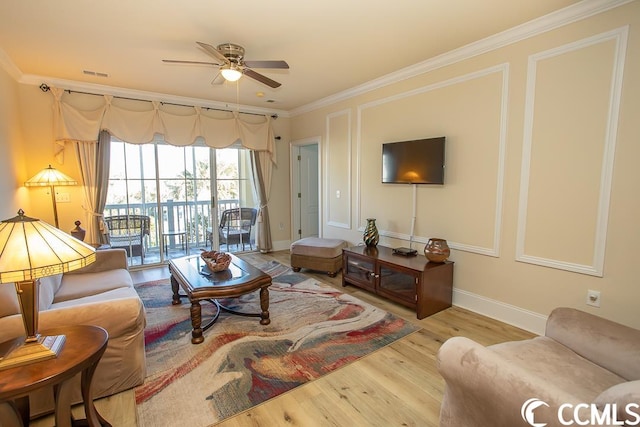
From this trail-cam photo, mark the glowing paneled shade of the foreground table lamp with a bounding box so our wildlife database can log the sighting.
[0,209,96,283]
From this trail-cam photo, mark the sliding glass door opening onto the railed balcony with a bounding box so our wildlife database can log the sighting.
[104,138,255,265]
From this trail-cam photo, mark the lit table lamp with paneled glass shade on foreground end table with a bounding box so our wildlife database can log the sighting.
[0,209,96,370]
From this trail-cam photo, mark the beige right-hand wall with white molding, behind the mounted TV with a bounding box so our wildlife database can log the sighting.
[291,2,640,332]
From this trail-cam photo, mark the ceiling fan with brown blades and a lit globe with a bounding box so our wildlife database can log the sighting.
[162,42,289,88]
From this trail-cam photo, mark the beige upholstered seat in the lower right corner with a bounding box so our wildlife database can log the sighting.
[437,308,640,427]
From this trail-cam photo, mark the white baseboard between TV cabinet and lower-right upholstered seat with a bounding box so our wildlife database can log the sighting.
[453,289,547,335]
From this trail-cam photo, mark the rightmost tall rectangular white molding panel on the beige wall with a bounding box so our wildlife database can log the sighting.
[516,27,629,277]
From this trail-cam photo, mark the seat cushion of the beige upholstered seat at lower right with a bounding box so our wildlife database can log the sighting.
[489,337,624,402]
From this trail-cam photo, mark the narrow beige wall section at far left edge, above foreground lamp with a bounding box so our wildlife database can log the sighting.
[0,67,29,220]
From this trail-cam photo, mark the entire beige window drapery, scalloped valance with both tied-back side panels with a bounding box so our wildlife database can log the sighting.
[51,88,276,252]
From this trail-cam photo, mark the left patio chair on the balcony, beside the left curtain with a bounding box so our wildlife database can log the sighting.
[104,215,150,263]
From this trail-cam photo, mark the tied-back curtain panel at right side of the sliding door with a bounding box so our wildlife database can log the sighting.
[251,151,273,253]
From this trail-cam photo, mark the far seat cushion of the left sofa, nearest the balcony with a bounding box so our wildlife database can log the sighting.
[53,269,133,303]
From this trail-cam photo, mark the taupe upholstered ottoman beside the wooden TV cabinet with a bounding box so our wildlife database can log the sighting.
[291,237,347,277]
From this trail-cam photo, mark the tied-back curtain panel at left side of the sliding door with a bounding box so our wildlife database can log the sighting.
[73,131,111,244]
